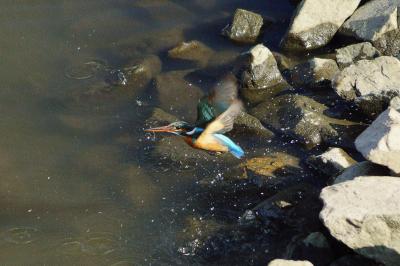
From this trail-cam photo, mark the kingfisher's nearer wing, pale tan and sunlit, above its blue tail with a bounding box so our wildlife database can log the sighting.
[199,99,243,138]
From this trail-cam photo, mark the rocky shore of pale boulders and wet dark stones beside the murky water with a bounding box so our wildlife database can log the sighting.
[122,0,400,266]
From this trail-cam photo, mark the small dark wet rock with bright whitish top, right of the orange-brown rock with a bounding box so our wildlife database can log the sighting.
[307,148,356,176]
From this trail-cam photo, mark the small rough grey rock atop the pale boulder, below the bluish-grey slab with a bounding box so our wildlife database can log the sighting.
[336,42,379,69]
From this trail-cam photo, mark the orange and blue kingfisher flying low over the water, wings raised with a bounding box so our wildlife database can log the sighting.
[145,73,244,159]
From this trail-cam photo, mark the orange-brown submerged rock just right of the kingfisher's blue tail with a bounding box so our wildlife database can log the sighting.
[239,152,302,187]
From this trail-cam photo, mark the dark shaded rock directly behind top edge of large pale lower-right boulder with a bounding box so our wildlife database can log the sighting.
[333,161,389,184]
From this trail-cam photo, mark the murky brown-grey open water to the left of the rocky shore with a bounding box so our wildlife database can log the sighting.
[0,0,293,265]
